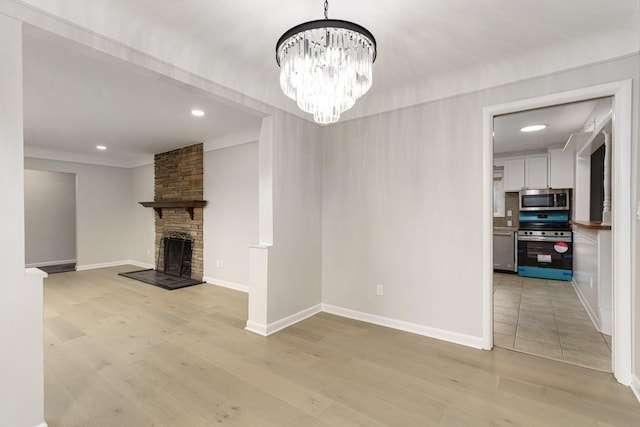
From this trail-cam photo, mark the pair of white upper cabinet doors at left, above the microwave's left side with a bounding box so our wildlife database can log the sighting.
[504,156,548,191]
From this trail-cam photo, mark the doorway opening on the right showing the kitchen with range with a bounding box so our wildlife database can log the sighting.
[493,97,612,372]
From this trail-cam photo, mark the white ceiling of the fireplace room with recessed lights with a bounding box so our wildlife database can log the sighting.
[23,31,261,166]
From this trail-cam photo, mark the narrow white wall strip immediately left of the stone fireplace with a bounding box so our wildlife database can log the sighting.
[129,164,157,268]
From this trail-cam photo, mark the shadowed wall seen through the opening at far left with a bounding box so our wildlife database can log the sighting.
[24,170,76,267]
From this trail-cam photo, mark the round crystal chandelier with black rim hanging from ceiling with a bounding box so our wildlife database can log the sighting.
[276,1,376,124]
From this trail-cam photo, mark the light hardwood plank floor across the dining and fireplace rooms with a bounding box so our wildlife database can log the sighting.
[44,266,640,427]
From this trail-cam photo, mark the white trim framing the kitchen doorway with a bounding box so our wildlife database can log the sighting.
[482,79,633,385]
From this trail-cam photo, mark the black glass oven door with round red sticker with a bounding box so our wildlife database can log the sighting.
[518,241,573,270]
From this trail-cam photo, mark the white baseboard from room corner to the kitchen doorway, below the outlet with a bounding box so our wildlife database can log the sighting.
[322,304,483,349]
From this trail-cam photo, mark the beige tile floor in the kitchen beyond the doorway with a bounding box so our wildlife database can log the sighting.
[493,273,611,372]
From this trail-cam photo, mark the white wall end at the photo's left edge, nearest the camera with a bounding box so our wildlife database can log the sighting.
[0,14,44,427]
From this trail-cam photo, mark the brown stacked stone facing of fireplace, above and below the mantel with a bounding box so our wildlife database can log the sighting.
[154,144,203,280]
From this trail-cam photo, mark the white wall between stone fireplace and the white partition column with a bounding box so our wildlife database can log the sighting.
[204,142,258,289]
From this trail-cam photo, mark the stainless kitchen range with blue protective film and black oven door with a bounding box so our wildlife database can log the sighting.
[517,211,573,281]
